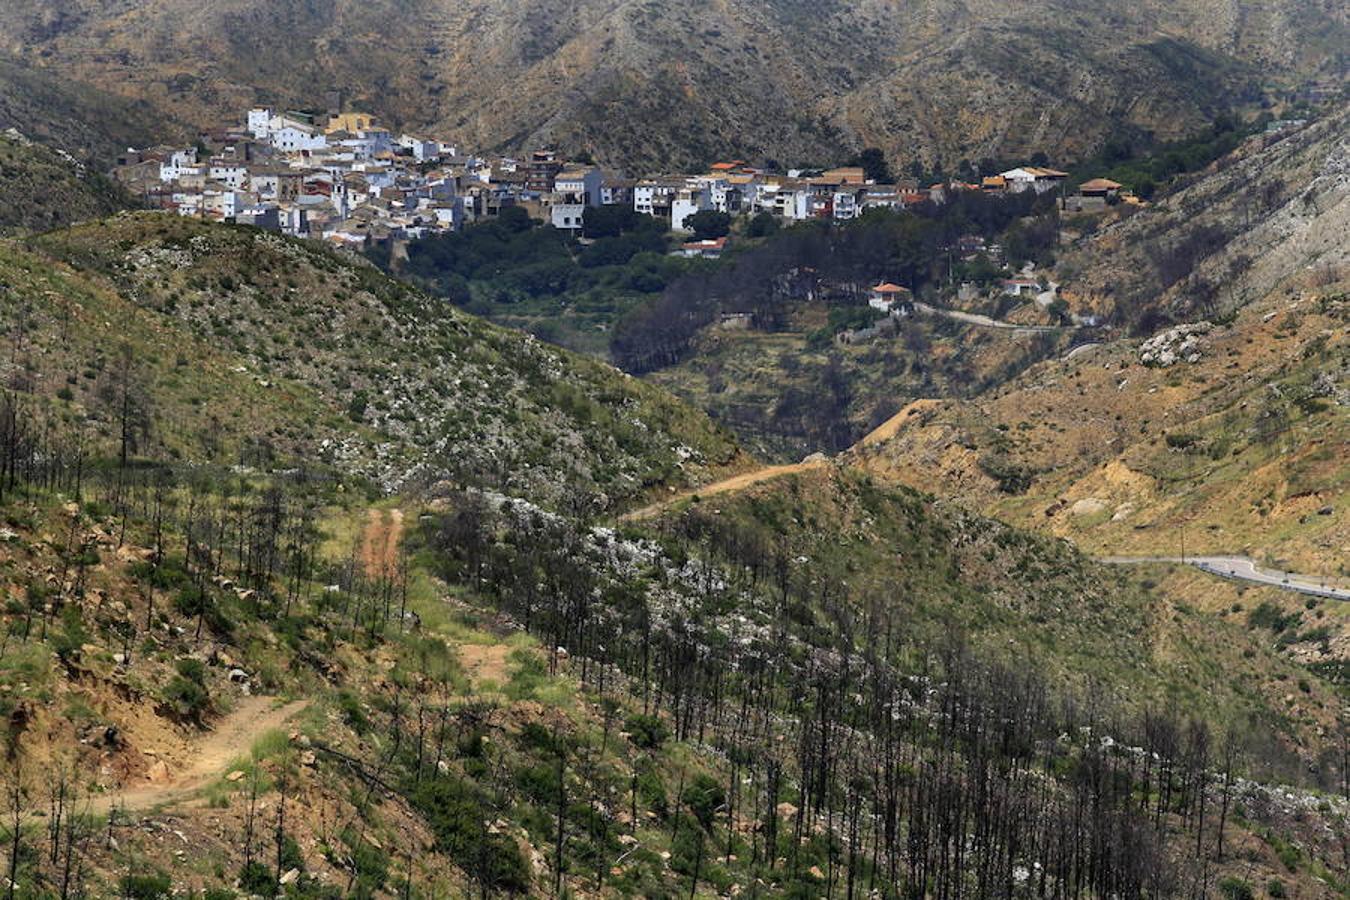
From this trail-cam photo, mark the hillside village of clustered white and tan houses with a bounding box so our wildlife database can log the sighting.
[113,108,1137,258]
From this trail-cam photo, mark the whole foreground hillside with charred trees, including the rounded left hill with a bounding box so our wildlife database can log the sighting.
[0,213,1347,899]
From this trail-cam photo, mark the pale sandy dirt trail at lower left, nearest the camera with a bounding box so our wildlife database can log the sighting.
[74,696,309,815]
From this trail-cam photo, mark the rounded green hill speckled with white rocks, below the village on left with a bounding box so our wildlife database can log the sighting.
[7,213,738,507]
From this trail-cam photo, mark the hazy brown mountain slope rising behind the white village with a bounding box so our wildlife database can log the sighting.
[0,0,1347,169]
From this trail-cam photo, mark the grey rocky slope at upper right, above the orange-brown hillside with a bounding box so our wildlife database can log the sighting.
[1061,107,1350,331]
